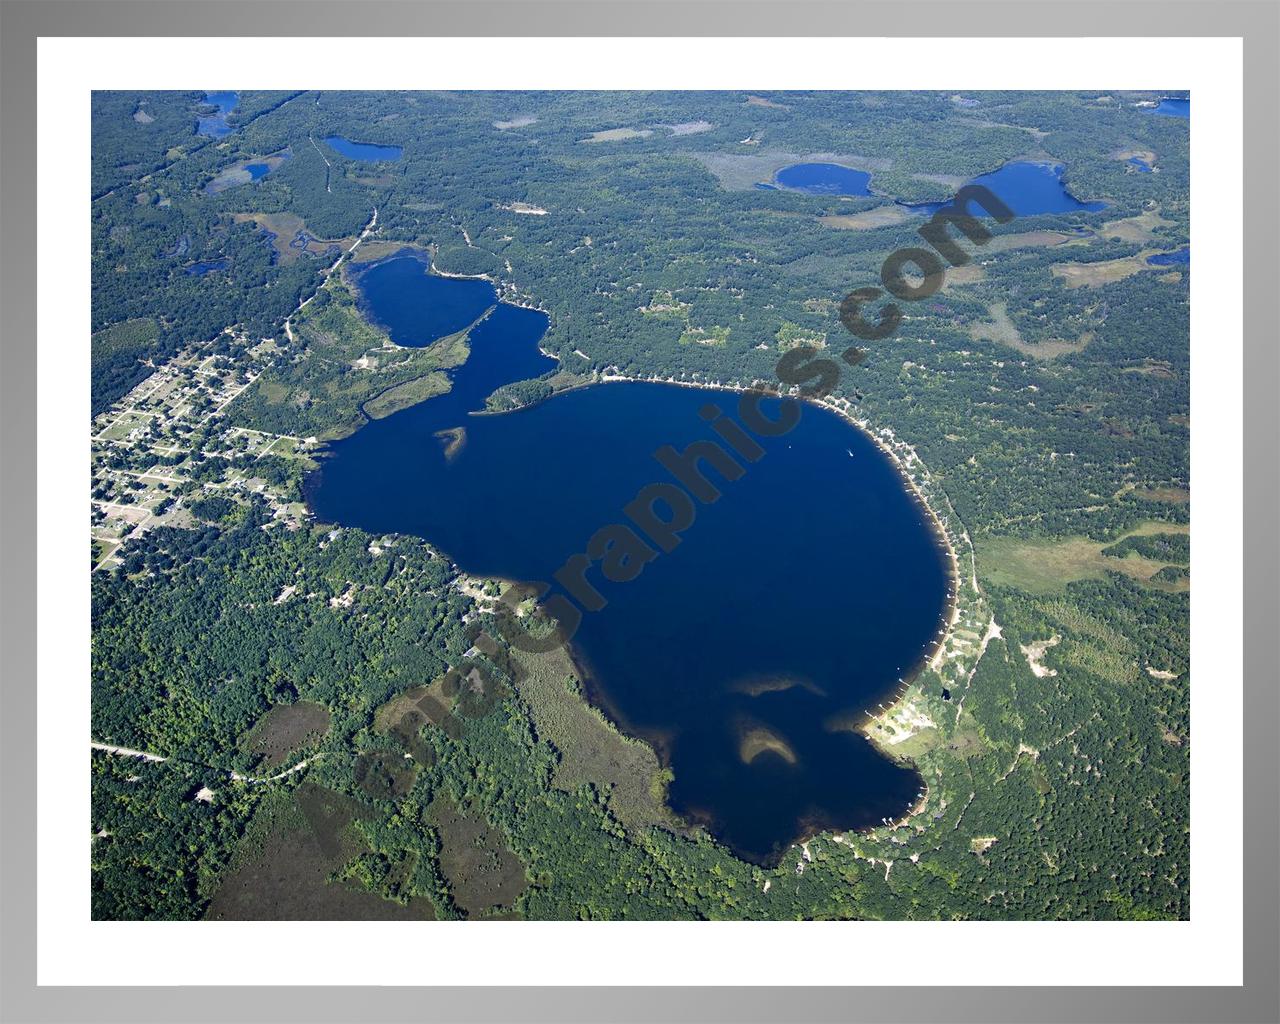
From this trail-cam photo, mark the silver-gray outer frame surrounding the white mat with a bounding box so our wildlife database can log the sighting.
[0,0,1280,1024]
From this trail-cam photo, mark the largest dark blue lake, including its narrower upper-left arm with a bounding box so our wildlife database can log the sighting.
[307,257,948,863]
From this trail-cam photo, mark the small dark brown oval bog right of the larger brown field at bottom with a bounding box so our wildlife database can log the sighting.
[428,794,529,916]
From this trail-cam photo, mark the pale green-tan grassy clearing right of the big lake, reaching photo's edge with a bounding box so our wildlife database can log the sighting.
[978,522,1189,594]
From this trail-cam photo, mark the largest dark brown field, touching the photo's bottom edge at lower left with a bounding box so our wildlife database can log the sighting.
[205,782,435,920]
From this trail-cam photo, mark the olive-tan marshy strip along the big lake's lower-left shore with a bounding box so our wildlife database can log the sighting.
[512,649,673,828]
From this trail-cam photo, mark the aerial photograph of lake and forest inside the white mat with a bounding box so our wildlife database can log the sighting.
[87,81,1192,934]
